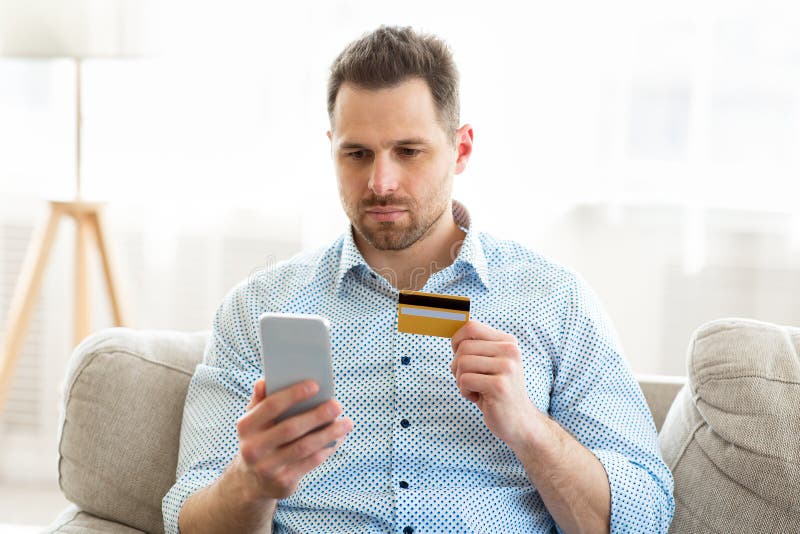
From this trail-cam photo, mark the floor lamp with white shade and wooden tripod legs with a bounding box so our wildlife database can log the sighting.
[0,0,158,411]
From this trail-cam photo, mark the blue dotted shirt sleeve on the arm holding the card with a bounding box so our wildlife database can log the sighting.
[550,276,675,533]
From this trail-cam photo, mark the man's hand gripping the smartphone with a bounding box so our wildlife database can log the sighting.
[236,379,353,499]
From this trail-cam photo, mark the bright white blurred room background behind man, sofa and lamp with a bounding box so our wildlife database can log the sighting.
[0,0,800,522]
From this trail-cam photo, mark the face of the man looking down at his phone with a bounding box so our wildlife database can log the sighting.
[328,78,471,250]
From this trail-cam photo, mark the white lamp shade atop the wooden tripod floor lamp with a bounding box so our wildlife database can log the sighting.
[0,0,158,59]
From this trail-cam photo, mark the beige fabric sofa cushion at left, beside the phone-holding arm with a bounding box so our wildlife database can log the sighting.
[59,328,207,532]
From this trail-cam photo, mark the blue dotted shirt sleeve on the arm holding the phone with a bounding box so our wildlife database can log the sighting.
[162,284,261,534]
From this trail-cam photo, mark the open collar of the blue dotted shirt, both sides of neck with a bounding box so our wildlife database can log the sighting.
[335,200,489,296]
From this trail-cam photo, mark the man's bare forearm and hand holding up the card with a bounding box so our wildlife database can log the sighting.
[450,321,611,532]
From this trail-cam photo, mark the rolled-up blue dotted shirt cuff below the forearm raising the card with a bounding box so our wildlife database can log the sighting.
[592,450,675,534]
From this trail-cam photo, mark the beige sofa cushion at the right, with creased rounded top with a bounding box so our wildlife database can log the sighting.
[659,319,800,532]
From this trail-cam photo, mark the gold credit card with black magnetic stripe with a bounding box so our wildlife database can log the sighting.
[397,290,469,337]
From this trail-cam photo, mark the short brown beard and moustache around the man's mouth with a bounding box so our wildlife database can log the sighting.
[344,194,449,250]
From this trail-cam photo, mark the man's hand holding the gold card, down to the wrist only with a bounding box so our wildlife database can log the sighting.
[450,321,543,451]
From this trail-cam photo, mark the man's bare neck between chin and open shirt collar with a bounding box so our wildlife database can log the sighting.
[353,209,466,290]
